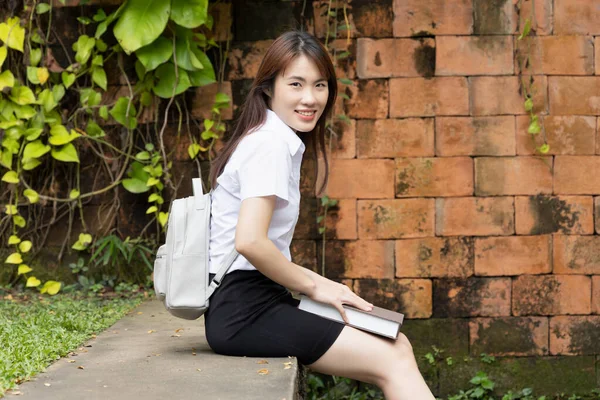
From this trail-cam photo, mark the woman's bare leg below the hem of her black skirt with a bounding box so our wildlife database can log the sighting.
[308,326,435,400]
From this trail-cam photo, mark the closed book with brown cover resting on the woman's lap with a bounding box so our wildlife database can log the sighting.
[298,295,404,339]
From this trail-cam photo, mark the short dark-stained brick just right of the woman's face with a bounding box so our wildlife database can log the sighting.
[346,79,389,119]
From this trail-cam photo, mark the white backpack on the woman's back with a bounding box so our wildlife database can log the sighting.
[154,178,238,319]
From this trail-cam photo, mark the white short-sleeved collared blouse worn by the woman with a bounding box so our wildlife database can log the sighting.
[209,110,305,274]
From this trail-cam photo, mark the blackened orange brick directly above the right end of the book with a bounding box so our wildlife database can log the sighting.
[354,279,432,318]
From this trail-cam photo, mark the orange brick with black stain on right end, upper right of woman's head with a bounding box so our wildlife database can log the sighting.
[356,38,439,79]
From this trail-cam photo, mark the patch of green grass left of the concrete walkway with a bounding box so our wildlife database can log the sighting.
[0,290,143,397]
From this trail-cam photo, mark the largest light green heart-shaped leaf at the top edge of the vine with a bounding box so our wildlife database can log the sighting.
[114,0,171,54]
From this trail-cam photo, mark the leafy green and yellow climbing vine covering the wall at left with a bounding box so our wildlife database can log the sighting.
[0,0,230,294]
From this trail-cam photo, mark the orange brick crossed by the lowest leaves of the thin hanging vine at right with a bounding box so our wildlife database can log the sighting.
[517,115,596,155]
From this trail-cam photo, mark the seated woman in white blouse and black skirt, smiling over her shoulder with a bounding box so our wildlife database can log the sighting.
[205,32,434,400]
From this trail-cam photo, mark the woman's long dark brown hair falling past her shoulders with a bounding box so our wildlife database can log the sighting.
[210,31,337,194]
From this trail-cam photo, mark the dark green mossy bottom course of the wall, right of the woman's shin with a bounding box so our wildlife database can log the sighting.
[436,356,597,398]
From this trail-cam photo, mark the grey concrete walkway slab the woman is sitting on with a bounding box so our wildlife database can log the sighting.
[6,300,298,400]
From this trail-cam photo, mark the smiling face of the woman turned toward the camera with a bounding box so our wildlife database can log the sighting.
[269,55,329,132]
